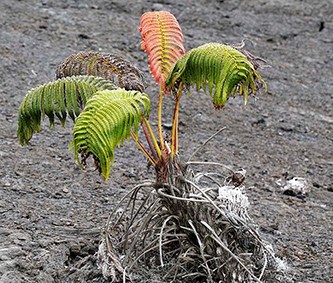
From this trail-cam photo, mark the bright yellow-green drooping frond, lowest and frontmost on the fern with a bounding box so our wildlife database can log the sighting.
[72,89,150,179]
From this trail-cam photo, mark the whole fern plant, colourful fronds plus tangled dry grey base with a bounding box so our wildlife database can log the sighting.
[17,11,280,282]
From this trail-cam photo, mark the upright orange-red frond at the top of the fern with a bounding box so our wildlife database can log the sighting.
[139,11,185,90]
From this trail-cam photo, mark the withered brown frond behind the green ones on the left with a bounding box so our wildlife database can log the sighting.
[56,52,145,92]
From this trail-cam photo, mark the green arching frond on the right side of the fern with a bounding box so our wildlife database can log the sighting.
[166,43,266,108]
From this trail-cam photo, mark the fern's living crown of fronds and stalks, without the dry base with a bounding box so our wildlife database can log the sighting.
[17,11,263,183]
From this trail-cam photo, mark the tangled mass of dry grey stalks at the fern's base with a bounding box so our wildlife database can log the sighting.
[99,163,284,283]
